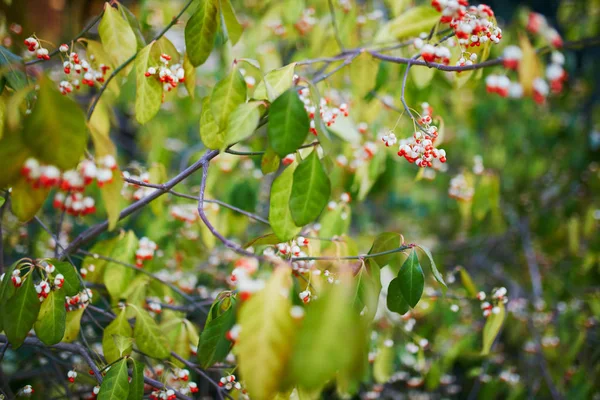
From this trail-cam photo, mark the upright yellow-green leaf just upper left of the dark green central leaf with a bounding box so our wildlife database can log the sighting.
[210,68,246,130]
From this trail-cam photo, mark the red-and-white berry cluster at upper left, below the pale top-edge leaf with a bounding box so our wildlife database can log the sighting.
[58,44,110,95]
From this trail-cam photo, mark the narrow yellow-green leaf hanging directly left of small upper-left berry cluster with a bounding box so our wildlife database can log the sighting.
[135,42,163,124]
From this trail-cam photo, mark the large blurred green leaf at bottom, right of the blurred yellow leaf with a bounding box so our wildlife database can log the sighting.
[289,276,367,389]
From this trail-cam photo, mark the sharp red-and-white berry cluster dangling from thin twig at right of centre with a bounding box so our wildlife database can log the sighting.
[396,103,446,168]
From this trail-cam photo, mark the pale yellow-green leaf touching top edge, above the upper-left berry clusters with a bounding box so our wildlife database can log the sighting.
[98,3,138,76]
